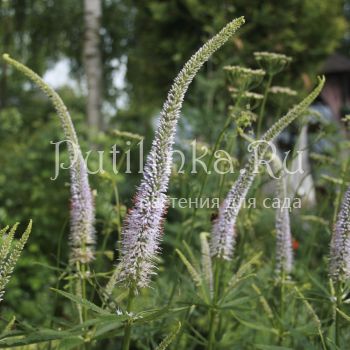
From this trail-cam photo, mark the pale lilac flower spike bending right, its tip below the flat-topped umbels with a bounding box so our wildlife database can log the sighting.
[210,77,325,260]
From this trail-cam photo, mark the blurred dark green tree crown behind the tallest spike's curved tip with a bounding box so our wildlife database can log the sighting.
[127,0,345,141]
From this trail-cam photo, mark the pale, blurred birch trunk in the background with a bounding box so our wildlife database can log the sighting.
[83,0,103,130]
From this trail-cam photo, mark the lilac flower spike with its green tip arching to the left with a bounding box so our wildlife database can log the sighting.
[3,54,95,263]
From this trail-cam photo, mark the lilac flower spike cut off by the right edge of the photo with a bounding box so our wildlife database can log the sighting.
[329,187,350,281]
